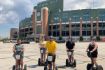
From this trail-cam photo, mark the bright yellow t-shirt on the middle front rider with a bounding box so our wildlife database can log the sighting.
[46,41,56,54]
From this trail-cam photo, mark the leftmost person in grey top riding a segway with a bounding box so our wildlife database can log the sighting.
[13,39,27,70]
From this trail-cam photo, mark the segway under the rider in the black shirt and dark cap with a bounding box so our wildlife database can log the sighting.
[66,50,76,67]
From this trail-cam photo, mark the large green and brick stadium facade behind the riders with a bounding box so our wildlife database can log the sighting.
[19,0,105,40]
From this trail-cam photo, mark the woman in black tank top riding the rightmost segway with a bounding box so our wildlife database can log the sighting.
[86,38,103,70]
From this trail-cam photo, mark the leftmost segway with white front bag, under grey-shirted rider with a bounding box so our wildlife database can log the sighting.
[12,51,27,70]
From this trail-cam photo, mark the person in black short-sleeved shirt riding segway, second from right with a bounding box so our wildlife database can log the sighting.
[66,38,76,67]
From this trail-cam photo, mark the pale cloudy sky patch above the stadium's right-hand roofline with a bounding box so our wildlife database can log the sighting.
[64,0,105,10]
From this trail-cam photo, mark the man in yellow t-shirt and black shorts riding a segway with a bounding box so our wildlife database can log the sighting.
[44,36,57,70]
